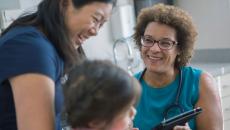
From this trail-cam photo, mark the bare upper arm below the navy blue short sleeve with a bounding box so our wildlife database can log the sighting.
[10,73,55,130]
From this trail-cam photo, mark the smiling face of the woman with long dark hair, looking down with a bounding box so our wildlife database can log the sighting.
[66,1,112,47]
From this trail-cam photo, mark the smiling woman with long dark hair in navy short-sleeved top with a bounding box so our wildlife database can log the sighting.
[0,0,116,130]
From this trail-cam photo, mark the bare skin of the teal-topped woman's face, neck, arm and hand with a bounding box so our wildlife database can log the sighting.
[141,22,223,130]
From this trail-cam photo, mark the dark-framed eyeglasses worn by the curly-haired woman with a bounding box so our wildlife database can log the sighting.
[141,36,177,50]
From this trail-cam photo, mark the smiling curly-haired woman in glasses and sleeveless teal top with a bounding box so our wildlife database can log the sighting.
[134,4,223,130]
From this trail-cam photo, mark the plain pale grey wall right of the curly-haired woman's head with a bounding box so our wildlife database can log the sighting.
[177,0,230,49]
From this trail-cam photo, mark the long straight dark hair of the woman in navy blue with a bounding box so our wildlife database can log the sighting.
[2,0,116,71]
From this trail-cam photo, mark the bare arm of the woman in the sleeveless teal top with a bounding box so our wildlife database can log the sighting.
[196,73,223,130]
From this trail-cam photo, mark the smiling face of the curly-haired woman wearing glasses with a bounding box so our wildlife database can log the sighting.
[141,22,179,73]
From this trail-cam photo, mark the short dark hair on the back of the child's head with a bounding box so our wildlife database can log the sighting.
[64,60,140,128]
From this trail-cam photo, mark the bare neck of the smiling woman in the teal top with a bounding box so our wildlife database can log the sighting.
[143,69,178,88]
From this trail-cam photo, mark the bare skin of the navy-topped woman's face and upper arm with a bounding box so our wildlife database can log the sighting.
[9,0,112,130]
